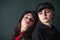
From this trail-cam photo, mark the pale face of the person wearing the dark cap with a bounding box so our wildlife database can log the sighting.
[38,8,54,23]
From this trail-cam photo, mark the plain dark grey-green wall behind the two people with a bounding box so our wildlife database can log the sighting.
[0,0,60,40]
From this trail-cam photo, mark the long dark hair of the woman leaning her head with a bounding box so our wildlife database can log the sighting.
[13,11,37,40]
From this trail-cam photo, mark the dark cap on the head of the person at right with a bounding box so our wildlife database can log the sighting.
[36,2,55,12]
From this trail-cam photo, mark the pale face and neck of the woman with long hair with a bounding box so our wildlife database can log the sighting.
[21,13,34,32]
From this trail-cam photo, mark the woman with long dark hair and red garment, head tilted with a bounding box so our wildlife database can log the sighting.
[13,11,37,40]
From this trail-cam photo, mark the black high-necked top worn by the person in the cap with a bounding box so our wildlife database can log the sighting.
[32,22,59,40]
